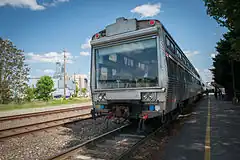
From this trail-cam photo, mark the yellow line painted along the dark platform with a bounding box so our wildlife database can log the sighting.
[204,98,211,160]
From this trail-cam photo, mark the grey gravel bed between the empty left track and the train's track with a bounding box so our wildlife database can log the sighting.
[0,118,123,160]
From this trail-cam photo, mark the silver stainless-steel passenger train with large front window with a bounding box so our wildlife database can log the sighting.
[90,17,205,121]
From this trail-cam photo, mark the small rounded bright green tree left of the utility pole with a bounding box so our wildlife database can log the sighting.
[35,76,54,101]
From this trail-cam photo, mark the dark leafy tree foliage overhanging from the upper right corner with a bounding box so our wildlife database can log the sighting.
[204,0,240,60]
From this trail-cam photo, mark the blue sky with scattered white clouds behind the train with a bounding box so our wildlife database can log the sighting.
[0,0,226,80]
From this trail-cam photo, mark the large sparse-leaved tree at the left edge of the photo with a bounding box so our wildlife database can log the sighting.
[0,38,29,103]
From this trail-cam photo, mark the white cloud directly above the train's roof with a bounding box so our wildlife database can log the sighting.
[131,3,161,18]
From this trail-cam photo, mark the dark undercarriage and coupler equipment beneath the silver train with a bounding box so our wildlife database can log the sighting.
[91,94,202,131]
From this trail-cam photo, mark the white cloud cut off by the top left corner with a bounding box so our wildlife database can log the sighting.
[0,0,45,10]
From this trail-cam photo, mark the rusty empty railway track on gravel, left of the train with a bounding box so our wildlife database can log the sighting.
[0,106,91,140]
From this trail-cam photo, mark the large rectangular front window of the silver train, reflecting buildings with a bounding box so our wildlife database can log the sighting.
[95,37,158,89]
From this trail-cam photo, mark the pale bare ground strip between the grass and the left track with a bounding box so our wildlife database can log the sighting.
[0,102,92,117]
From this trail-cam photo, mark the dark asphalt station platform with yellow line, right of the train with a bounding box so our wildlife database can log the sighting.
[160,96,240,160]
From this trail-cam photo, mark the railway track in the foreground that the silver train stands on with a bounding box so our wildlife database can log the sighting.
[49,110,184,160]
